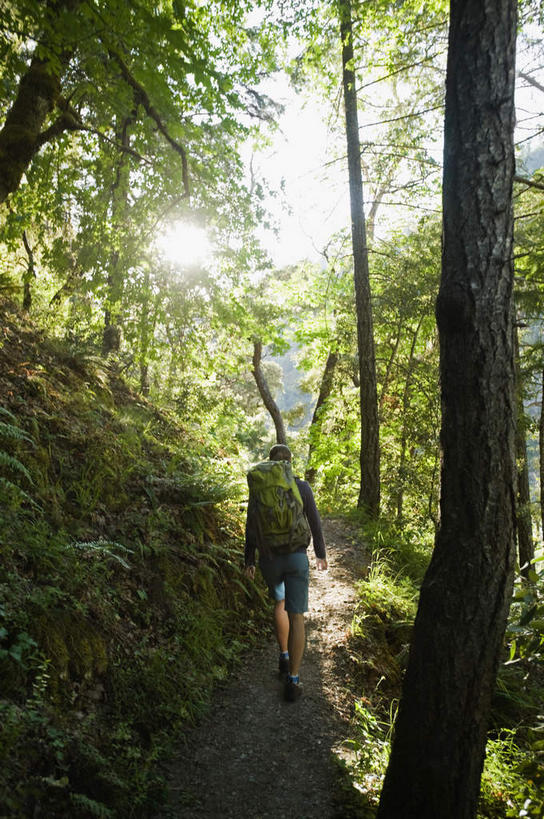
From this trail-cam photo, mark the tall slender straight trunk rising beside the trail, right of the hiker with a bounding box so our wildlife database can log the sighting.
[338,0,380,517]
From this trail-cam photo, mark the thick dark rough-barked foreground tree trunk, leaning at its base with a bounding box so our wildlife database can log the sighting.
[377,0,516,819]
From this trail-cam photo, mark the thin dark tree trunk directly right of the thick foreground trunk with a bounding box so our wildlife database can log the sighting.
[514,326,535,578]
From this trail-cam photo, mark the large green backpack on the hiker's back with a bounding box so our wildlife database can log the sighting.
[247,461,311,554]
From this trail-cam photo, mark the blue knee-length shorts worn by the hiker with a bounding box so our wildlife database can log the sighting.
[259,552,310,614]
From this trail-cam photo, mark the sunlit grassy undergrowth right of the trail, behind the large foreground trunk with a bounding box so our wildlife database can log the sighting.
[336,522,544,819]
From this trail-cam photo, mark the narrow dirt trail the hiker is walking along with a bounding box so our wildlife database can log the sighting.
[162,520,366,819]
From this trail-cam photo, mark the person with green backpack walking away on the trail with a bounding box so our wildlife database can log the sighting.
[245,444,327,702]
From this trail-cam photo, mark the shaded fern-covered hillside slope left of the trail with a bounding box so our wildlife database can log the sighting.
[0,302,263,817]
